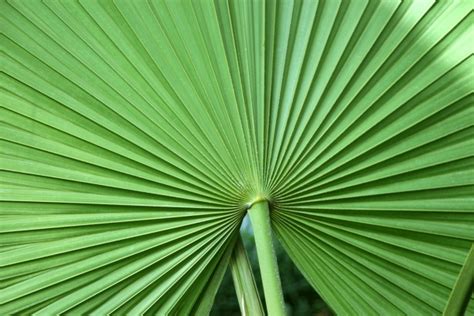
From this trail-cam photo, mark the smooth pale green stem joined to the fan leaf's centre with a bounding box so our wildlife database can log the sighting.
[248,201,285,316]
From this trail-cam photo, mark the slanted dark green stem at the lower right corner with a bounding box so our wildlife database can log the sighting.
[443,243,474,316]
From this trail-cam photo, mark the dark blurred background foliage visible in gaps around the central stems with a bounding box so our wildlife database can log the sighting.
[211,217,333,316]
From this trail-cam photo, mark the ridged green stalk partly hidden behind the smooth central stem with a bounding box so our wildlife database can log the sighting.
[230,236,265,316]
